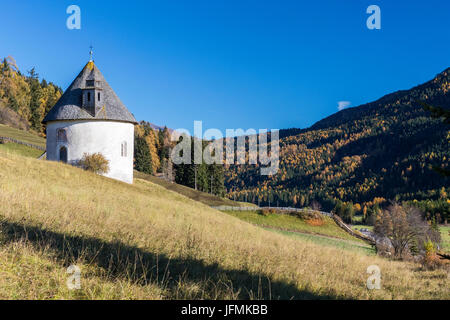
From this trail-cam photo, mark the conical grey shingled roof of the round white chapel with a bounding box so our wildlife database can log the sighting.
[42,61,137,123]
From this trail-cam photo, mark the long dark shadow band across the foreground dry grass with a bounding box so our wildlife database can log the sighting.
[0,220,336,299]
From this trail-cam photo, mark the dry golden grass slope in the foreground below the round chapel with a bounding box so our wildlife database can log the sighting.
[0,151,450,299]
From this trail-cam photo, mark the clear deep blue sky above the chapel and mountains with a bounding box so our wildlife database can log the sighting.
[0,0,450,130]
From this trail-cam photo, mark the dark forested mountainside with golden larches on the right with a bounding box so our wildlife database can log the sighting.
[226,68,450,220]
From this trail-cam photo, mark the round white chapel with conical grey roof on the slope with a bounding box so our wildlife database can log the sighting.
[43,60,137,183]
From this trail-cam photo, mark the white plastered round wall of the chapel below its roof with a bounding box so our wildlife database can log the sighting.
[47,120,134,183]
